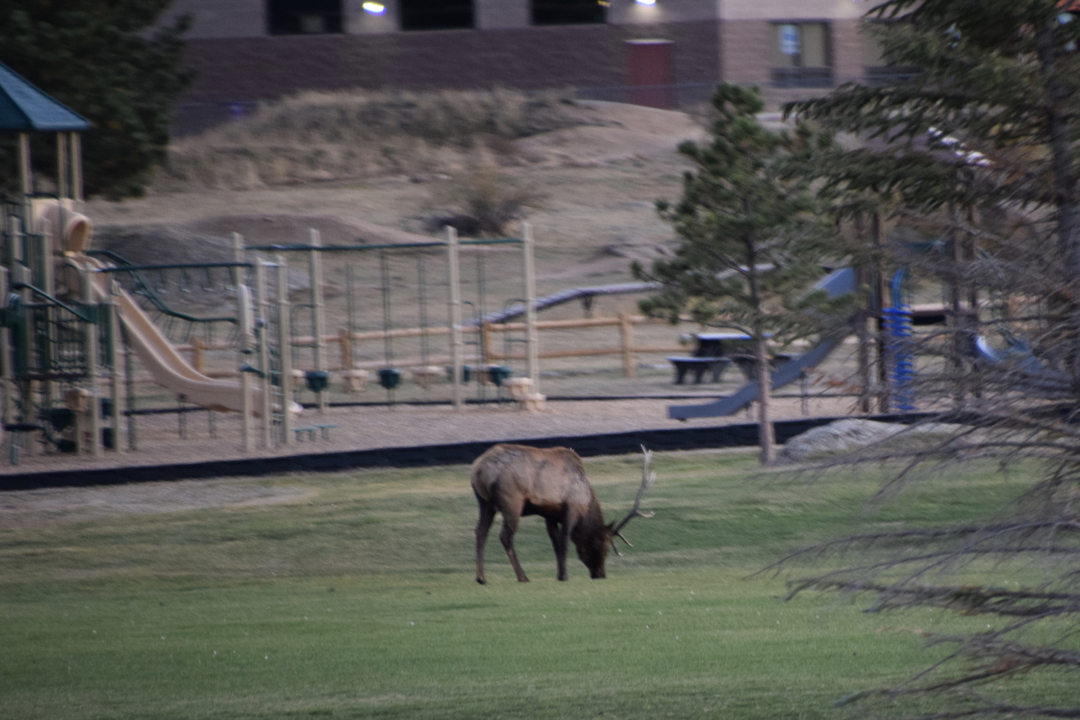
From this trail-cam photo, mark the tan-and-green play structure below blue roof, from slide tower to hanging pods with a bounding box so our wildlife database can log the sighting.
[0,185,543,464]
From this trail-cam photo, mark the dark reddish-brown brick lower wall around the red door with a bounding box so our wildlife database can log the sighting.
[184,22,721,103]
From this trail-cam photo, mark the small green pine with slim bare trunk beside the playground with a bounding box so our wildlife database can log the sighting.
[635,84,823,465]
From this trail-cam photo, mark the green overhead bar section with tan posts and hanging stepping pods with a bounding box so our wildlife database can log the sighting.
[247,225,540,408]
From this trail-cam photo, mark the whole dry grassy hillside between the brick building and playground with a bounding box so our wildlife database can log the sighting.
[87,91,702,289]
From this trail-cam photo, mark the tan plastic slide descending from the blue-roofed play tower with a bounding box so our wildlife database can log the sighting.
[80,258,282,415]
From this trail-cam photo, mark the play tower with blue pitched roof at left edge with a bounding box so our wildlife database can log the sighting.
[0,64,99,462]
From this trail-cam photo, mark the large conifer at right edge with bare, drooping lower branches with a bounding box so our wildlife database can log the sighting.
[786,0,1080,720]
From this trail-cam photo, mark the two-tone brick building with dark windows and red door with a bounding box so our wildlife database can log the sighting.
[170,0,879,131]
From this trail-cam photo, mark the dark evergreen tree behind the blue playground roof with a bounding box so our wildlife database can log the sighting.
[0,0,190,198]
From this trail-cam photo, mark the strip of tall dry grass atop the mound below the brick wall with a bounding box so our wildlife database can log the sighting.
[157,89,581,190]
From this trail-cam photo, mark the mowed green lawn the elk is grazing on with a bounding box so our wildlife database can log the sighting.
[0,452,1045,720]
